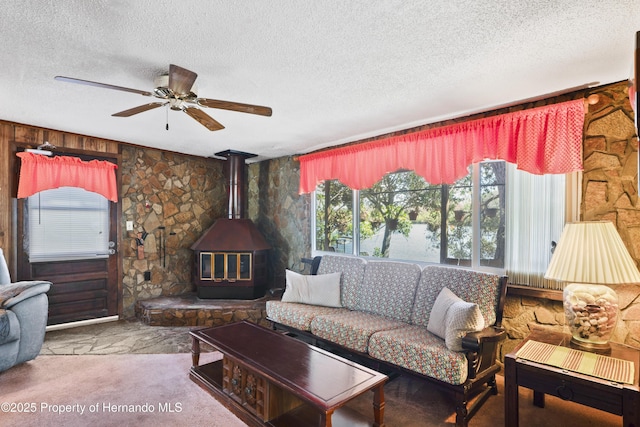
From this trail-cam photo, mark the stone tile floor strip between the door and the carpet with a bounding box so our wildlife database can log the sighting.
[40,319,195,355]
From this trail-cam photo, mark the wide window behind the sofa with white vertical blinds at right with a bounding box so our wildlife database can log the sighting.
[313,161,565,284]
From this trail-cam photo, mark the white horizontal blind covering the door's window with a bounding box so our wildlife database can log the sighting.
[27,187,109,262]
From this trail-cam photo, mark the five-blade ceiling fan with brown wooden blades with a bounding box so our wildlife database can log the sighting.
[54,64,271,131]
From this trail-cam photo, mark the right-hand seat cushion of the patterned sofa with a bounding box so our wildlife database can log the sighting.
[369,326,468,385]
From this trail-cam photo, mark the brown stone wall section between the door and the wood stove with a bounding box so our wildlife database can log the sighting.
[121,146,226,317]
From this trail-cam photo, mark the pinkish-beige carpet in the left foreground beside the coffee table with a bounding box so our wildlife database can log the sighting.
[0,353,245,427]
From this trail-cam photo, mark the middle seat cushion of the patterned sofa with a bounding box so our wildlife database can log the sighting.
[311,311,406,353]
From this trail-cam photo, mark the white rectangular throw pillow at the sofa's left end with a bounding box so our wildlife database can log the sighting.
[282,270,342,307]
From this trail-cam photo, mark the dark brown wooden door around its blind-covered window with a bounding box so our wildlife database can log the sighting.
[17,153,120,325]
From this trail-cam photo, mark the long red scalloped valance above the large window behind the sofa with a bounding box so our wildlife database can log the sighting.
[298,99,585,194]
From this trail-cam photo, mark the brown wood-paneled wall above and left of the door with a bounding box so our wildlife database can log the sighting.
[0,121,121,274]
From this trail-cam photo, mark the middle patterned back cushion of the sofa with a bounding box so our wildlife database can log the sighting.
[358,261,421,322]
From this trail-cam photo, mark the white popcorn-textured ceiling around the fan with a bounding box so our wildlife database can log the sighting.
[0,0,640,160]
